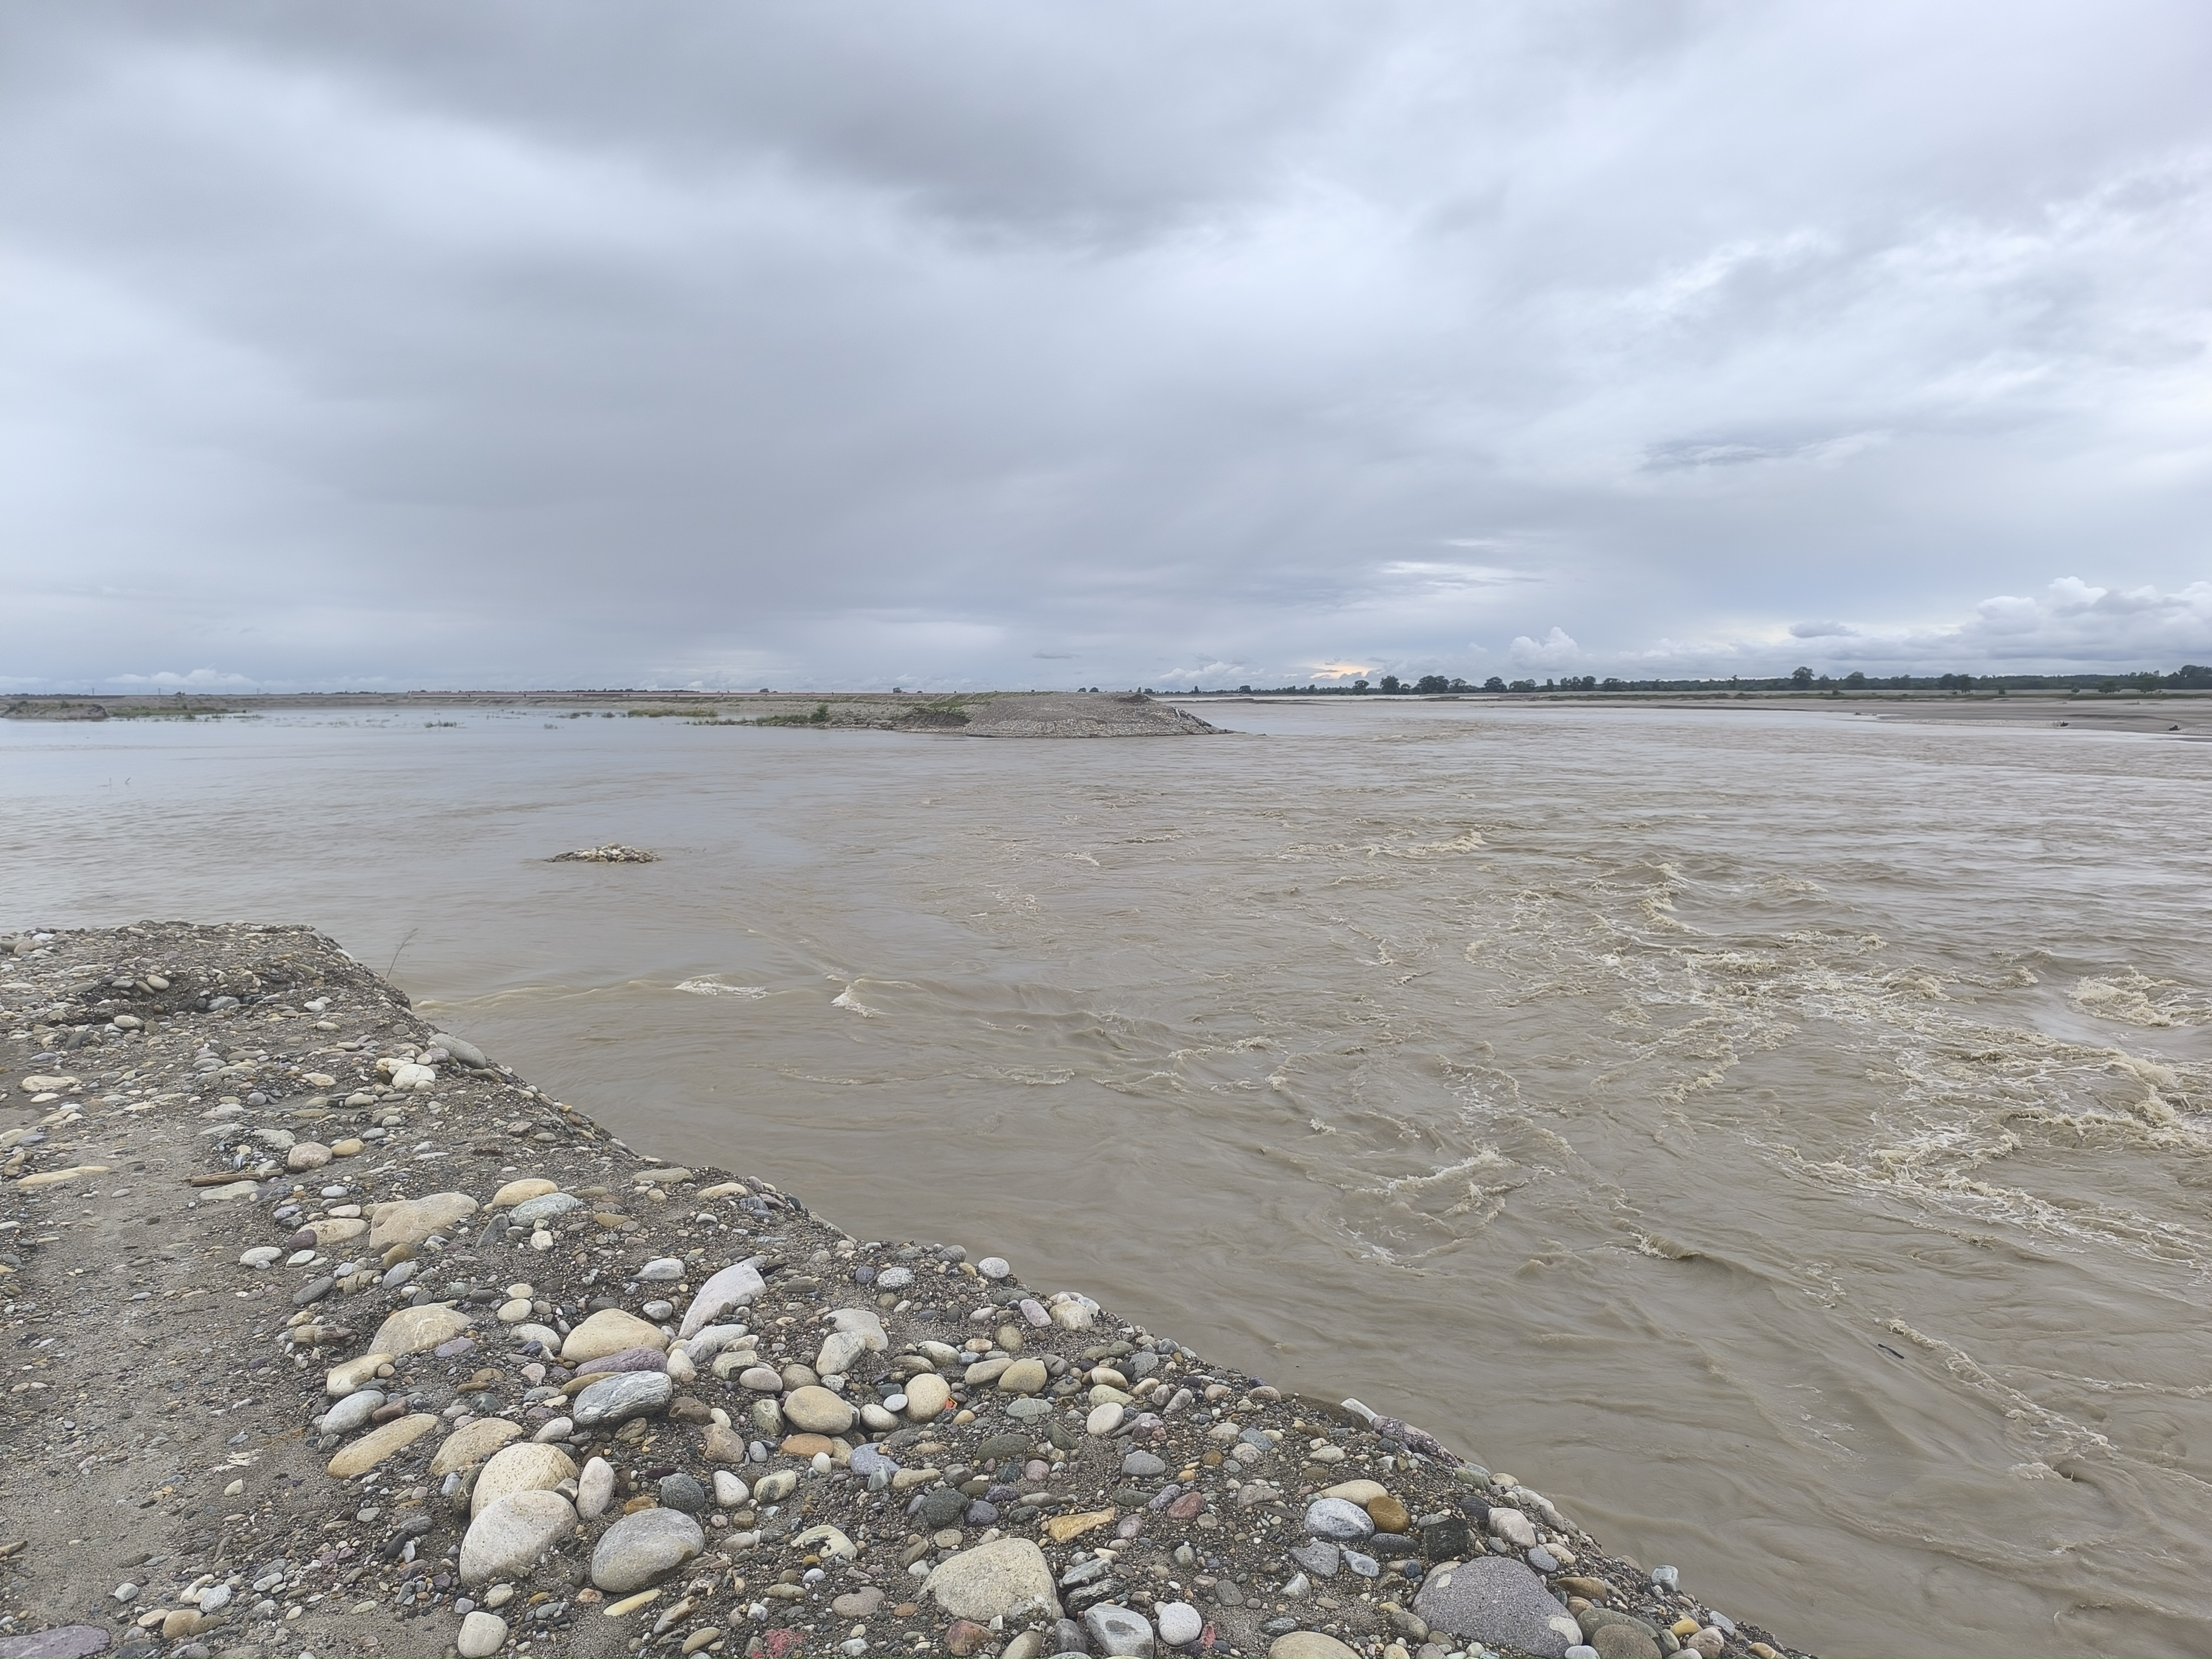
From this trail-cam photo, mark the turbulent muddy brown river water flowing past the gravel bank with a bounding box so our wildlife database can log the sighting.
[0,703,2212,1659]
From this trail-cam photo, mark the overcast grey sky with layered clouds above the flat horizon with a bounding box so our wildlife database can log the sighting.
[0,0,2212,690]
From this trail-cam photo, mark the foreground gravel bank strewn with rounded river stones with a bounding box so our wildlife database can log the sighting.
[0,924,1780,1659]
